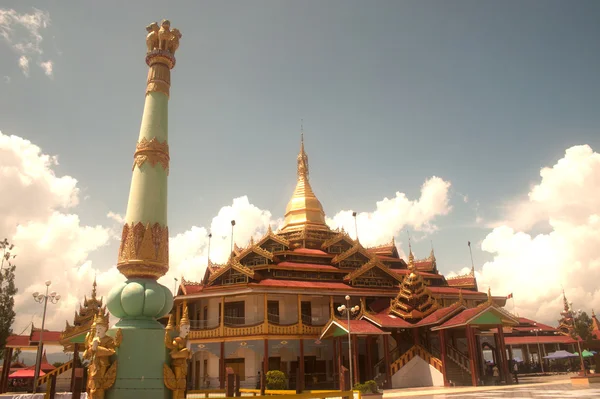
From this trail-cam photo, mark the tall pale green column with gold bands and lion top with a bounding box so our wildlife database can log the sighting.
[106,20,181,399]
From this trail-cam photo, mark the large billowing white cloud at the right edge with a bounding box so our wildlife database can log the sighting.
[478,145,600,324]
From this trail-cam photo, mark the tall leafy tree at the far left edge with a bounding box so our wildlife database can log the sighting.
[0,238,17,355]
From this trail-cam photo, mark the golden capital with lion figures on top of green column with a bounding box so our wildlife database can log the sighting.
[146,19,182,96]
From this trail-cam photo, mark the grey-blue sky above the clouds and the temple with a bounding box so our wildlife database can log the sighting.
[0,0,600,332]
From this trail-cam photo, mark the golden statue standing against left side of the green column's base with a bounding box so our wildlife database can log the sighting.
[83,309,123,399]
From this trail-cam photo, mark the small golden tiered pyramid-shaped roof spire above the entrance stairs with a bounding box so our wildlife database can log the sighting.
[390,251,440,320]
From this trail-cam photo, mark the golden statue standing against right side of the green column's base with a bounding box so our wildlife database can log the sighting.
[163,304,192,399]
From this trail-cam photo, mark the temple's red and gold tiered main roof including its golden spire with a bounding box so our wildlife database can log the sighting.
[178,136,506,323]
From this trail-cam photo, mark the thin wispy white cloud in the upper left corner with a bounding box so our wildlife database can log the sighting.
[0,8,52,76]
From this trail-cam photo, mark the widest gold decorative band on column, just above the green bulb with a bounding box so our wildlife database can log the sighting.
[117,222,169,279]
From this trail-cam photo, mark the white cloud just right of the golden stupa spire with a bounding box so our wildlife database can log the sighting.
[327,176,452,246]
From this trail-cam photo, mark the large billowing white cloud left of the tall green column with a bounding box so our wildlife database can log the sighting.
[0,133,115,332]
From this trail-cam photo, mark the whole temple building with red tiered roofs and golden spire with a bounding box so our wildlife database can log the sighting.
[174,141,520,389]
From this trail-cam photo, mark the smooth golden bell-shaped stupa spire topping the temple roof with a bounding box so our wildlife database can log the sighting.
[281,129,329,232]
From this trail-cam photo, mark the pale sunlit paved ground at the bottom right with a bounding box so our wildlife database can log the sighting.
[384,380,600,399]
